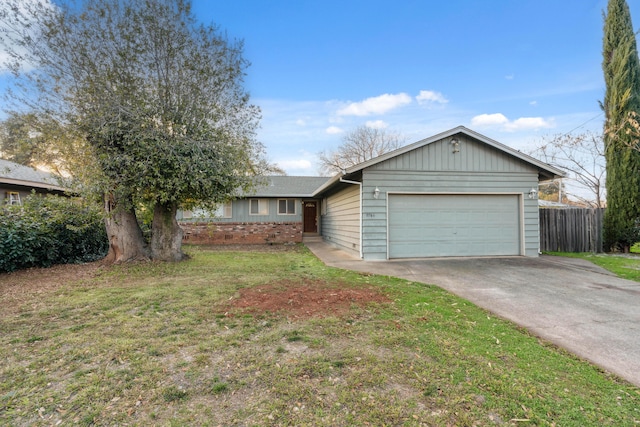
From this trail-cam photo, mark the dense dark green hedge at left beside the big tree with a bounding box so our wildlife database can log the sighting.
[0,195,109,272]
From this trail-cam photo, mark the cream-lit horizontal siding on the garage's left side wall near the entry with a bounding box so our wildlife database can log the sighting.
[321,184,360,256]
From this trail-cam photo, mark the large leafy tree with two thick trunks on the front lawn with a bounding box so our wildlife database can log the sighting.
[2,0,264,261]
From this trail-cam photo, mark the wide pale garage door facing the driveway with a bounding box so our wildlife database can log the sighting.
[389,194,521,258]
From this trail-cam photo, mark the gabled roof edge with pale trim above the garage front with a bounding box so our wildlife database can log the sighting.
[314,126,565,195]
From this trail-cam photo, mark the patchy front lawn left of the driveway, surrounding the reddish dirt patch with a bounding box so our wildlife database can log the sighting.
[0,247,640,426]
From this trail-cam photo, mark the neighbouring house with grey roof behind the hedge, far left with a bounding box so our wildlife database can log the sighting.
[0,159,66,205]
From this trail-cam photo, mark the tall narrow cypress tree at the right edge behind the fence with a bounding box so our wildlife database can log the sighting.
[602,0,640,251]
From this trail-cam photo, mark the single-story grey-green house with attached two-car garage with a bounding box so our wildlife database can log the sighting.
[179,126,564,260]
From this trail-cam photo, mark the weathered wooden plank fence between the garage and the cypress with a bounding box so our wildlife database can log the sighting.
[540,208,604,252]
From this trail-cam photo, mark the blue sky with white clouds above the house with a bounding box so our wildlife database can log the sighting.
[0,0,640,175]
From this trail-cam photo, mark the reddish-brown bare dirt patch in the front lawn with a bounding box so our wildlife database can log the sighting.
[230,280,391,319]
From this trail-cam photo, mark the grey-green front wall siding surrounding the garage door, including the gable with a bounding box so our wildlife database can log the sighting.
[362,139,539,260]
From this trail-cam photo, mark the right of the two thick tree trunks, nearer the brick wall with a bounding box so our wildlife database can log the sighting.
[151,203,186,261]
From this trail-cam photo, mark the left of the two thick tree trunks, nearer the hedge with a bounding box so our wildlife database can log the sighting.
[105,197,150,263]
